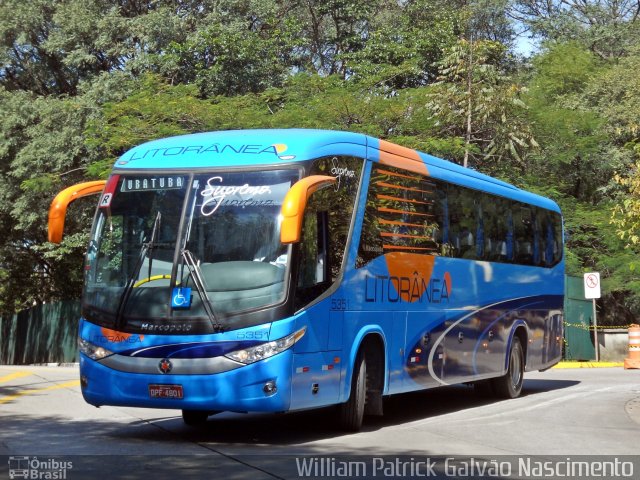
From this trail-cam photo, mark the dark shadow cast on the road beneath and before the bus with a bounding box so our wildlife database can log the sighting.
[0,380,579,455]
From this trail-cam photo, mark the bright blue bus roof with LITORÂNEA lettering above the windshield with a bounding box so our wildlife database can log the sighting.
[115,129,559,211]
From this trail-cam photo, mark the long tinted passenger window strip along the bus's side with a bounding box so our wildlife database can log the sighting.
[357,165,562,267]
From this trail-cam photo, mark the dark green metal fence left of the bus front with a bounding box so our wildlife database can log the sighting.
[0,301,80,365]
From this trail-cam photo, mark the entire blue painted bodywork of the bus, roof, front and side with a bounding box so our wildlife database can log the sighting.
[80,129,564,412]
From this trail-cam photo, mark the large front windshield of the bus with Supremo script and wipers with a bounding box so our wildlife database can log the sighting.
[83,169,299,328]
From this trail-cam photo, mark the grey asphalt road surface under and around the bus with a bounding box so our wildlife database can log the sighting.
[0,366,640,480]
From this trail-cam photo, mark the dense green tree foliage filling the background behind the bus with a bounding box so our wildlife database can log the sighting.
[0,0,640,324]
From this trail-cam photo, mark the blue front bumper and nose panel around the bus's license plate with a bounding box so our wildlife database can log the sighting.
[79,319,295,412]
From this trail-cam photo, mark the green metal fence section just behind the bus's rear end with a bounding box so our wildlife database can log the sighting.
[564,276,596,360]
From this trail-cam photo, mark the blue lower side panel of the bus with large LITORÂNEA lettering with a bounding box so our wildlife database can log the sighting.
[318,257,564,401]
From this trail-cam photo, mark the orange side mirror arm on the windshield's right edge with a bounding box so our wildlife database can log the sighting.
[280,175,336,244]
